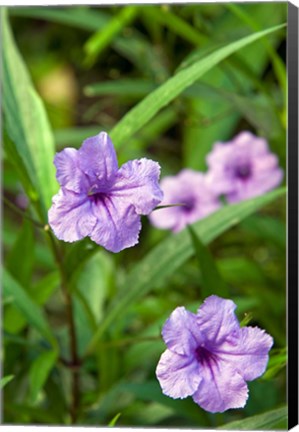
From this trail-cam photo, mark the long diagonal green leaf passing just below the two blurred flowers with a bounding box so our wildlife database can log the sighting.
[87,188,285,353]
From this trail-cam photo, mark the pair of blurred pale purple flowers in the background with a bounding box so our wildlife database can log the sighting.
[150,132,283,232]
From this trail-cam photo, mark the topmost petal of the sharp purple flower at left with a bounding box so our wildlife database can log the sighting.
[78,132,118,186]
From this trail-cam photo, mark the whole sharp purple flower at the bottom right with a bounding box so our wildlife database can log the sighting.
[156,295,273,413]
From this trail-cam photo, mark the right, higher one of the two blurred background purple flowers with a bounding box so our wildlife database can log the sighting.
[207,132,283,203]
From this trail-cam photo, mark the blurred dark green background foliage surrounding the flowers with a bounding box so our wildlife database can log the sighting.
[2,2,287,429]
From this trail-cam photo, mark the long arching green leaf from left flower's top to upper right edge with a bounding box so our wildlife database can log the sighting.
[111,25,284,145]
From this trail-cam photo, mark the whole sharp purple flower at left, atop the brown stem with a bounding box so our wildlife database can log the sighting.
[49,132,163,252]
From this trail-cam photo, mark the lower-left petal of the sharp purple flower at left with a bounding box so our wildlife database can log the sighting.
[48,189,97,242]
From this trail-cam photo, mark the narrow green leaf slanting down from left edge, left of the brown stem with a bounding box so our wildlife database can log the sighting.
[2,269,56,346]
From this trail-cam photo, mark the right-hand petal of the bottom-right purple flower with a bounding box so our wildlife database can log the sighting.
[215,327,273,381]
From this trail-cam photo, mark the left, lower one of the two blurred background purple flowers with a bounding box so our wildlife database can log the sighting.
[150,169,220,232]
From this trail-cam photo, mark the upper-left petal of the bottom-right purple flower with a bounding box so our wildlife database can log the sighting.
[162,307,202,355]
